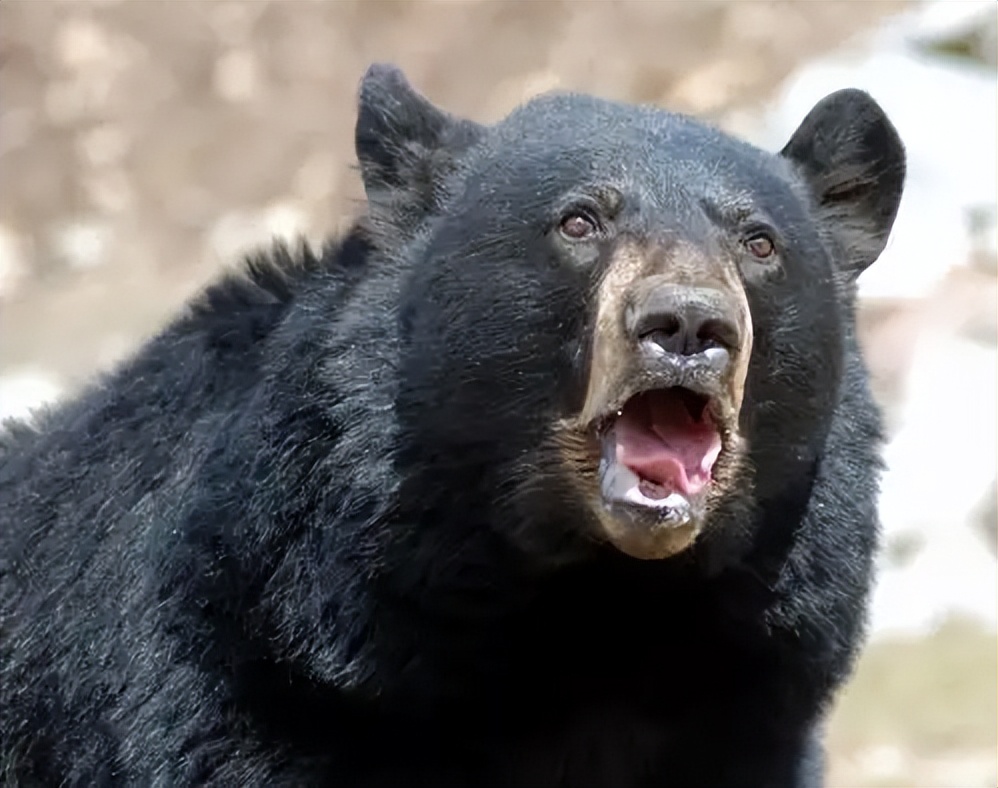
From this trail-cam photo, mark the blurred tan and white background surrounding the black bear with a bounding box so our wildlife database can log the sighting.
[0,0,998,788]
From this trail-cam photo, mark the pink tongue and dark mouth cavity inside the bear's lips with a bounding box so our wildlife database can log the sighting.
[614,392,721,495]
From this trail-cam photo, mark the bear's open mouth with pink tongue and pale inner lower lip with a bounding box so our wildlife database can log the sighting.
[600,387,721,519]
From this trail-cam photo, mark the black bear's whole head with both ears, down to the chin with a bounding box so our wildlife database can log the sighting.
[357,67,904,562]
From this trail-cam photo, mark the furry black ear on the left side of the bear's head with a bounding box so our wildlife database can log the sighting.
[355,64,484,244]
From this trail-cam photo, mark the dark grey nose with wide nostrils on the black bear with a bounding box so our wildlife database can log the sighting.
[627,285,741,356]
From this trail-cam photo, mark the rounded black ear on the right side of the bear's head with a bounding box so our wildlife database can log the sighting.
[780,89,905,278]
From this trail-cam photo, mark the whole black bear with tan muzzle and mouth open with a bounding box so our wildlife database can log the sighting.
[0,66,905,788]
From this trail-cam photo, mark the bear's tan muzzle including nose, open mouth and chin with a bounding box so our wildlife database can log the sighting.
[585,286,748,558]
